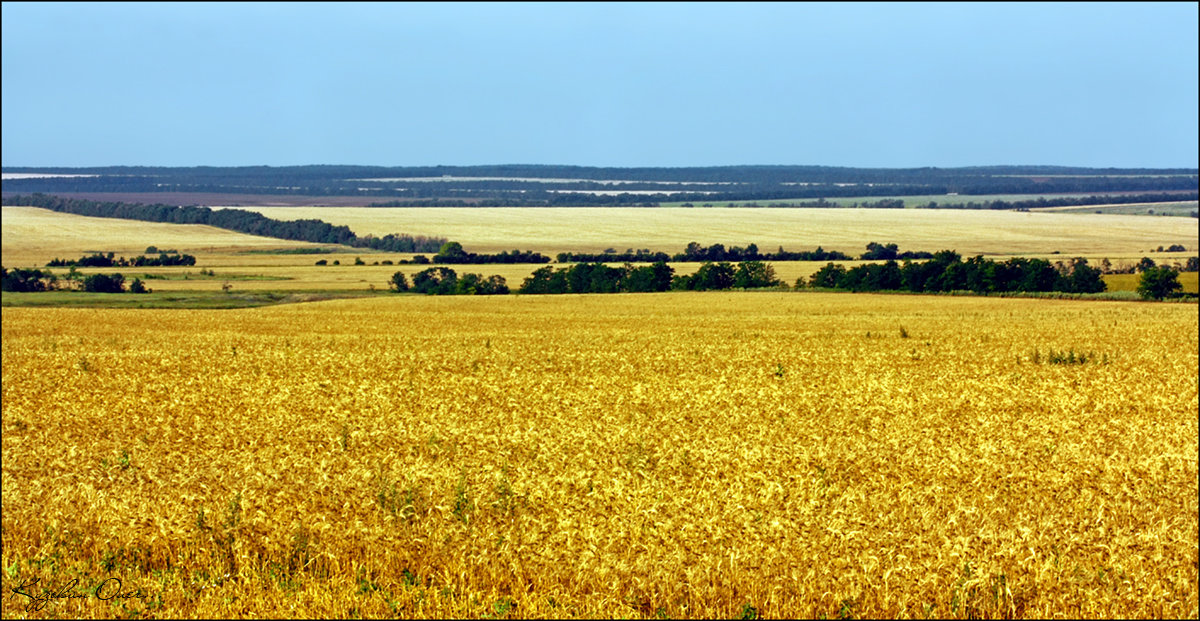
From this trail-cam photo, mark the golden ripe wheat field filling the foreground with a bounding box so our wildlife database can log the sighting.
[0,291,1200,619]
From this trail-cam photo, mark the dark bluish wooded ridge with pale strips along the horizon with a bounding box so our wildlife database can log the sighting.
[4,164,1200,206]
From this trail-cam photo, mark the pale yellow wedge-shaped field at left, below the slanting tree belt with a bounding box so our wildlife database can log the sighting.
[0,207,314,267]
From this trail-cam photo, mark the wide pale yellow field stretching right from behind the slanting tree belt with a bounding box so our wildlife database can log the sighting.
[229,207,1198,257]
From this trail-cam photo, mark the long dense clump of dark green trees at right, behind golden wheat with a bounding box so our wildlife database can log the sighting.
[797,251,1106,294]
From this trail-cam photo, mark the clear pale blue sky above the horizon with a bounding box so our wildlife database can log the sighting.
[0,2,1200,168]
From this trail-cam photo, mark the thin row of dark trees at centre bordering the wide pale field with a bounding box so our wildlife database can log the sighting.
[557,241,934,263]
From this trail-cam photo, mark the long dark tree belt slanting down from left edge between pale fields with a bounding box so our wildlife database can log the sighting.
[4,193,446,252]
